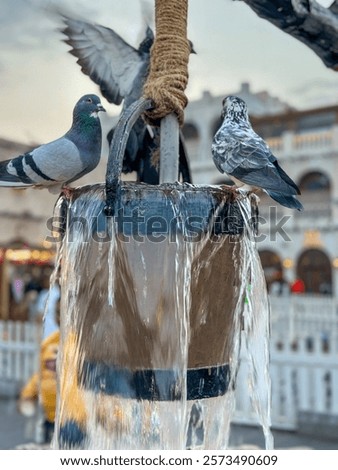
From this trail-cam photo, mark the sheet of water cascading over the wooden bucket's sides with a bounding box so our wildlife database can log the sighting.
[53,183,273,449]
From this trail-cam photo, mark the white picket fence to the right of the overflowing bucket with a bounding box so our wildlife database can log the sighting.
[234,296,338,430]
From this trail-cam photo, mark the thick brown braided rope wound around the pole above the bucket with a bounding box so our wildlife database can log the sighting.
[143,0,191,125]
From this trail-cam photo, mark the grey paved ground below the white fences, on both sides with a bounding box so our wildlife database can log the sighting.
[0,399,338,450]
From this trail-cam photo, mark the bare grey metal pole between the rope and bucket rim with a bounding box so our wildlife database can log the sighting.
[160,113,179,183]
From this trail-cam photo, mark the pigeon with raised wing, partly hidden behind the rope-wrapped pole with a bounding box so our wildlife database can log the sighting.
[61,13,191,184]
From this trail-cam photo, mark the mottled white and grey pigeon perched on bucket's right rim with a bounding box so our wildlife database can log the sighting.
[211,96,303,210]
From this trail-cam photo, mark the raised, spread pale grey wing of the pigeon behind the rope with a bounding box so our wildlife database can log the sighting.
[62,17,143,105]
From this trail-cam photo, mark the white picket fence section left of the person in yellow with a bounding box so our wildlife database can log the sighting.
[0,321,41,393]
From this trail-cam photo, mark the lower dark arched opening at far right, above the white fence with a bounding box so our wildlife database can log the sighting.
[297,248,332,295]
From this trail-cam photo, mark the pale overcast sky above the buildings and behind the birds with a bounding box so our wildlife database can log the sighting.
[0,0,338,143]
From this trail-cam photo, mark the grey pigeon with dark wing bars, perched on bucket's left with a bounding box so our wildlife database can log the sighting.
[0,95,105,193]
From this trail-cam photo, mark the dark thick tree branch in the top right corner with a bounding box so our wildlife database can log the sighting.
[242,0,338,71]
